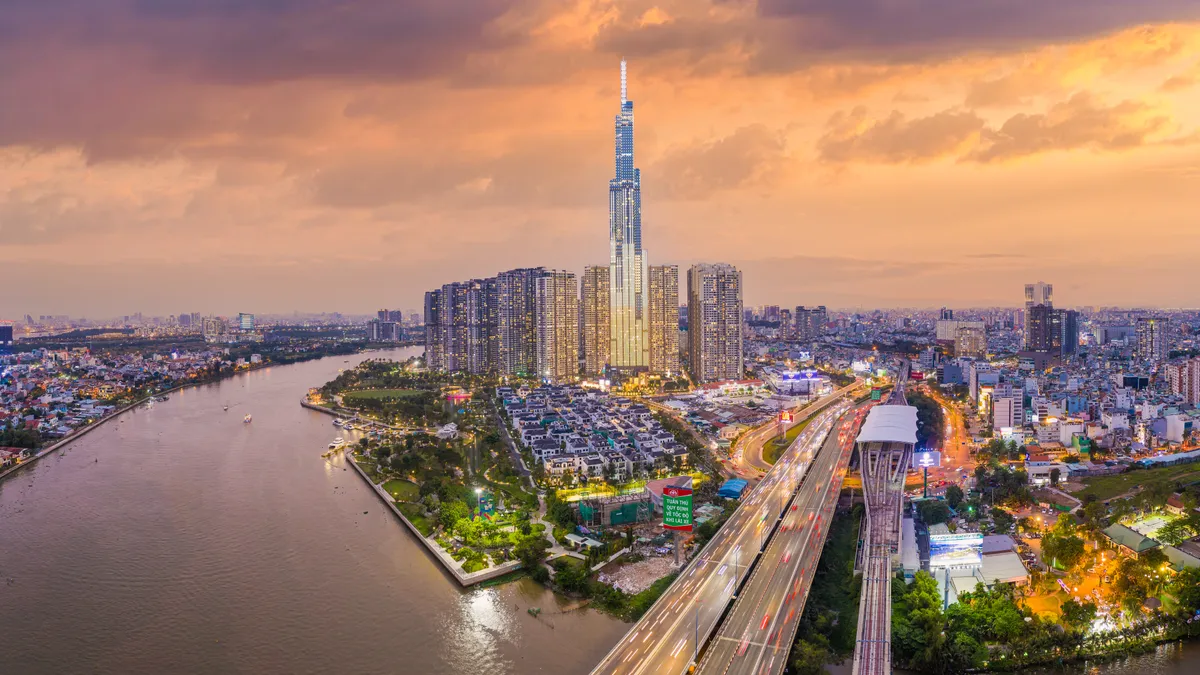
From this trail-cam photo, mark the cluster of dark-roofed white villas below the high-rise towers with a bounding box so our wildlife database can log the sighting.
[497,386,688,482]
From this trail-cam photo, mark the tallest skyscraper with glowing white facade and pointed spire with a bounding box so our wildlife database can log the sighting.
[608,60,649,370]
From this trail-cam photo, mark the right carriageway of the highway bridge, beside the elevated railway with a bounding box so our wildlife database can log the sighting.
[698,405,869,675]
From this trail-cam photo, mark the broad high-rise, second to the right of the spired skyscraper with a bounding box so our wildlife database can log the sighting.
[688,263,743,382]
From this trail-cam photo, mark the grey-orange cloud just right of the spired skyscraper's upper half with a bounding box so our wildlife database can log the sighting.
[646,124,786,199]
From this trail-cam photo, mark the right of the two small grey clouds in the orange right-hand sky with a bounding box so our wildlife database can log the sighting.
[965,94,1171,162]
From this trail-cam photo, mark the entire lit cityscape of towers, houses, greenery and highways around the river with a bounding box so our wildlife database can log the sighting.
[7,61,1200,675]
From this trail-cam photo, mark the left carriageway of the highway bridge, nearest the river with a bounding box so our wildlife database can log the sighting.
[593,404,846,675]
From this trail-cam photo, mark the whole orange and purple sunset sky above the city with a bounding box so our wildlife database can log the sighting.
[0,0,1200,318]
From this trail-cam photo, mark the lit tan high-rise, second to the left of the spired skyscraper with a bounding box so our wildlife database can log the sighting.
[535,270,580,382]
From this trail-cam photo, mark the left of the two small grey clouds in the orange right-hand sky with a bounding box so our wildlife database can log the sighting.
[817,107,984,163]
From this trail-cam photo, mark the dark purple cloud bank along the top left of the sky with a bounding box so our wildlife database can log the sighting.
[0,0,517,83]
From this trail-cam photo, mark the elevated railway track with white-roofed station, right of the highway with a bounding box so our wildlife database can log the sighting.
[852,363,917,675]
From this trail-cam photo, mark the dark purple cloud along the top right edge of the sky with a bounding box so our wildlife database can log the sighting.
[758,0,1200,55]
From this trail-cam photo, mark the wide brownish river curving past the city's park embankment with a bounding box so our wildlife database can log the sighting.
[0,348,628,675]
